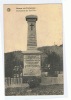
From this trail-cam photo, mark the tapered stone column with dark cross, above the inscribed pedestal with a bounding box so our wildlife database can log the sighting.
[26,15,37,50]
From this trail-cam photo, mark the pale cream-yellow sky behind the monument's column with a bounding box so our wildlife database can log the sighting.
[4,4,63,52]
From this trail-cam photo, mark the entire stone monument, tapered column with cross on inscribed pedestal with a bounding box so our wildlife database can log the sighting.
[23,15,41,81]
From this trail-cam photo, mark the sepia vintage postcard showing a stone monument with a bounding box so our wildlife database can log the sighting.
[4,4,64,96]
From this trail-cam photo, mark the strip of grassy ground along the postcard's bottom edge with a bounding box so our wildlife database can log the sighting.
[5,85,64,96]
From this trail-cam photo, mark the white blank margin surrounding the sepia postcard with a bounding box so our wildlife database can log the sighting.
[0,0,68,100]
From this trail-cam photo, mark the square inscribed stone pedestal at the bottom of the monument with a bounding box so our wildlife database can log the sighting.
[23,50,41,83]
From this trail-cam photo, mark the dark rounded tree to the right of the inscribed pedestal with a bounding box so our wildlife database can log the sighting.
[43,52,61,76]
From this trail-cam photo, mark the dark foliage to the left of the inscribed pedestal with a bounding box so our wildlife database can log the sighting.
[5,51,23,77]
